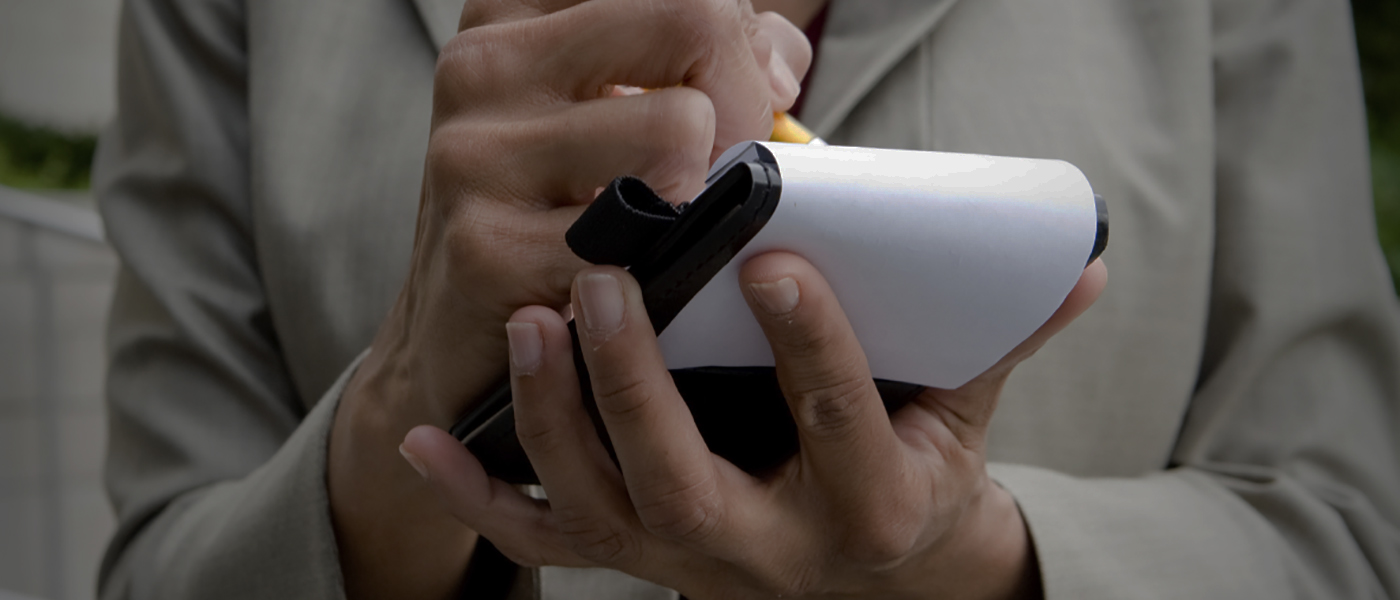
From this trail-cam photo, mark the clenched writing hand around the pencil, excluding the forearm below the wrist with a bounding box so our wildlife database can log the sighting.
[375,0,811,424]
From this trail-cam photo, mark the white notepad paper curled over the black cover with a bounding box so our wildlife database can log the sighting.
[659,143,1100,389]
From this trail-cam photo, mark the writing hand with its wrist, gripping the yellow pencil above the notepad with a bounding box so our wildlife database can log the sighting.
[328,0,811,597]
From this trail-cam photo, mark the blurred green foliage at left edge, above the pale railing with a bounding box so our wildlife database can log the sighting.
[0,115,97,189]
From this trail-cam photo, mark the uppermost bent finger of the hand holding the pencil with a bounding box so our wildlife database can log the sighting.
[434,0,773,158]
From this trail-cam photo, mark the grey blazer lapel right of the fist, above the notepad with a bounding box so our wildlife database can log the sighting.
[802,0,958,136]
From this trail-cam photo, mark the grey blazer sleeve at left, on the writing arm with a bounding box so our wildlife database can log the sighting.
[97,0,349,600]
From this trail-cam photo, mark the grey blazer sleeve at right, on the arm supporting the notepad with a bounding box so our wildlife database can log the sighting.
[993,0,1400,599]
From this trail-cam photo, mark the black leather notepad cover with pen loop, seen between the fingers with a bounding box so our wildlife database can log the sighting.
[452,144,923,484]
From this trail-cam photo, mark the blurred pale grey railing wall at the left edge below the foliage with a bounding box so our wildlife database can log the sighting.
[0,181,116,600]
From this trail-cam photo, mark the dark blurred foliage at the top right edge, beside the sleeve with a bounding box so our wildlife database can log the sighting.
[1351,0,1400,292]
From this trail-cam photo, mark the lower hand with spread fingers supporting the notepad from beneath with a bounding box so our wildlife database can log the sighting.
[403,253,1106,599]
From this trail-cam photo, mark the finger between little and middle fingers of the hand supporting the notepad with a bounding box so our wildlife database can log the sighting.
[505,306,647,569]
